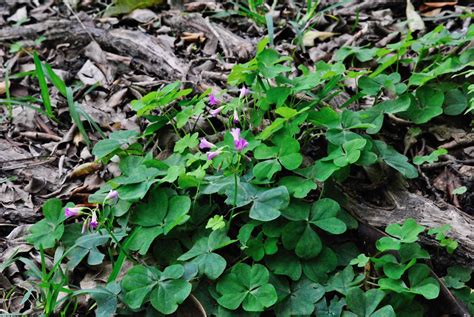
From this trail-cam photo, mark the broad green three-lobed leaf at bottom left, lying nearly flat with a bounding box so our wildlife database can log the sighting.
[122,264,191,314]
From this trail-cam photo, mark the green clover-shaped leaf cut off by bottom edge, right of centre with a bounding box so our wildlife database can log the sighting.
[346,288,396,317]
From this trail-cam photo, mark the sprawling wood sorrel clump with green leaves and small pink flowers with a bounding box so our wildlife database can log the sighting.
[19,28,473,316]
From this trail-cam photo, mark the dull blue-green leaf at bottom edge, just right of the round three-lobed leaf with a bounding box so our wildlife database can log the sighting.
[275,278,325,316]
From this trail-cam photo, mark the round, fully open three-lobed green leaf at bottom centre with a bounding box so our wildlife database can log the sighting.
[216,263,277,312]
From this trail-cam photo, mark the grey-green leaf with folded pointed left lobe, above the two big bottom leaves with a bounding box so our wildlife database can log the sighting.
[178,230,235,280]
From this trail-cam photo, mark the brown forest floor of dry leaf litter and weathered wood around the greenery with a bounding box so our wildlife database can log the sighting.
[0,0,474,314]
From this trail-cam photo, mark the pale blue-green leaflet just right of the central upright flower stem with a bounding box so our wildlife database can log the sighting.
[249,186,290,221]
